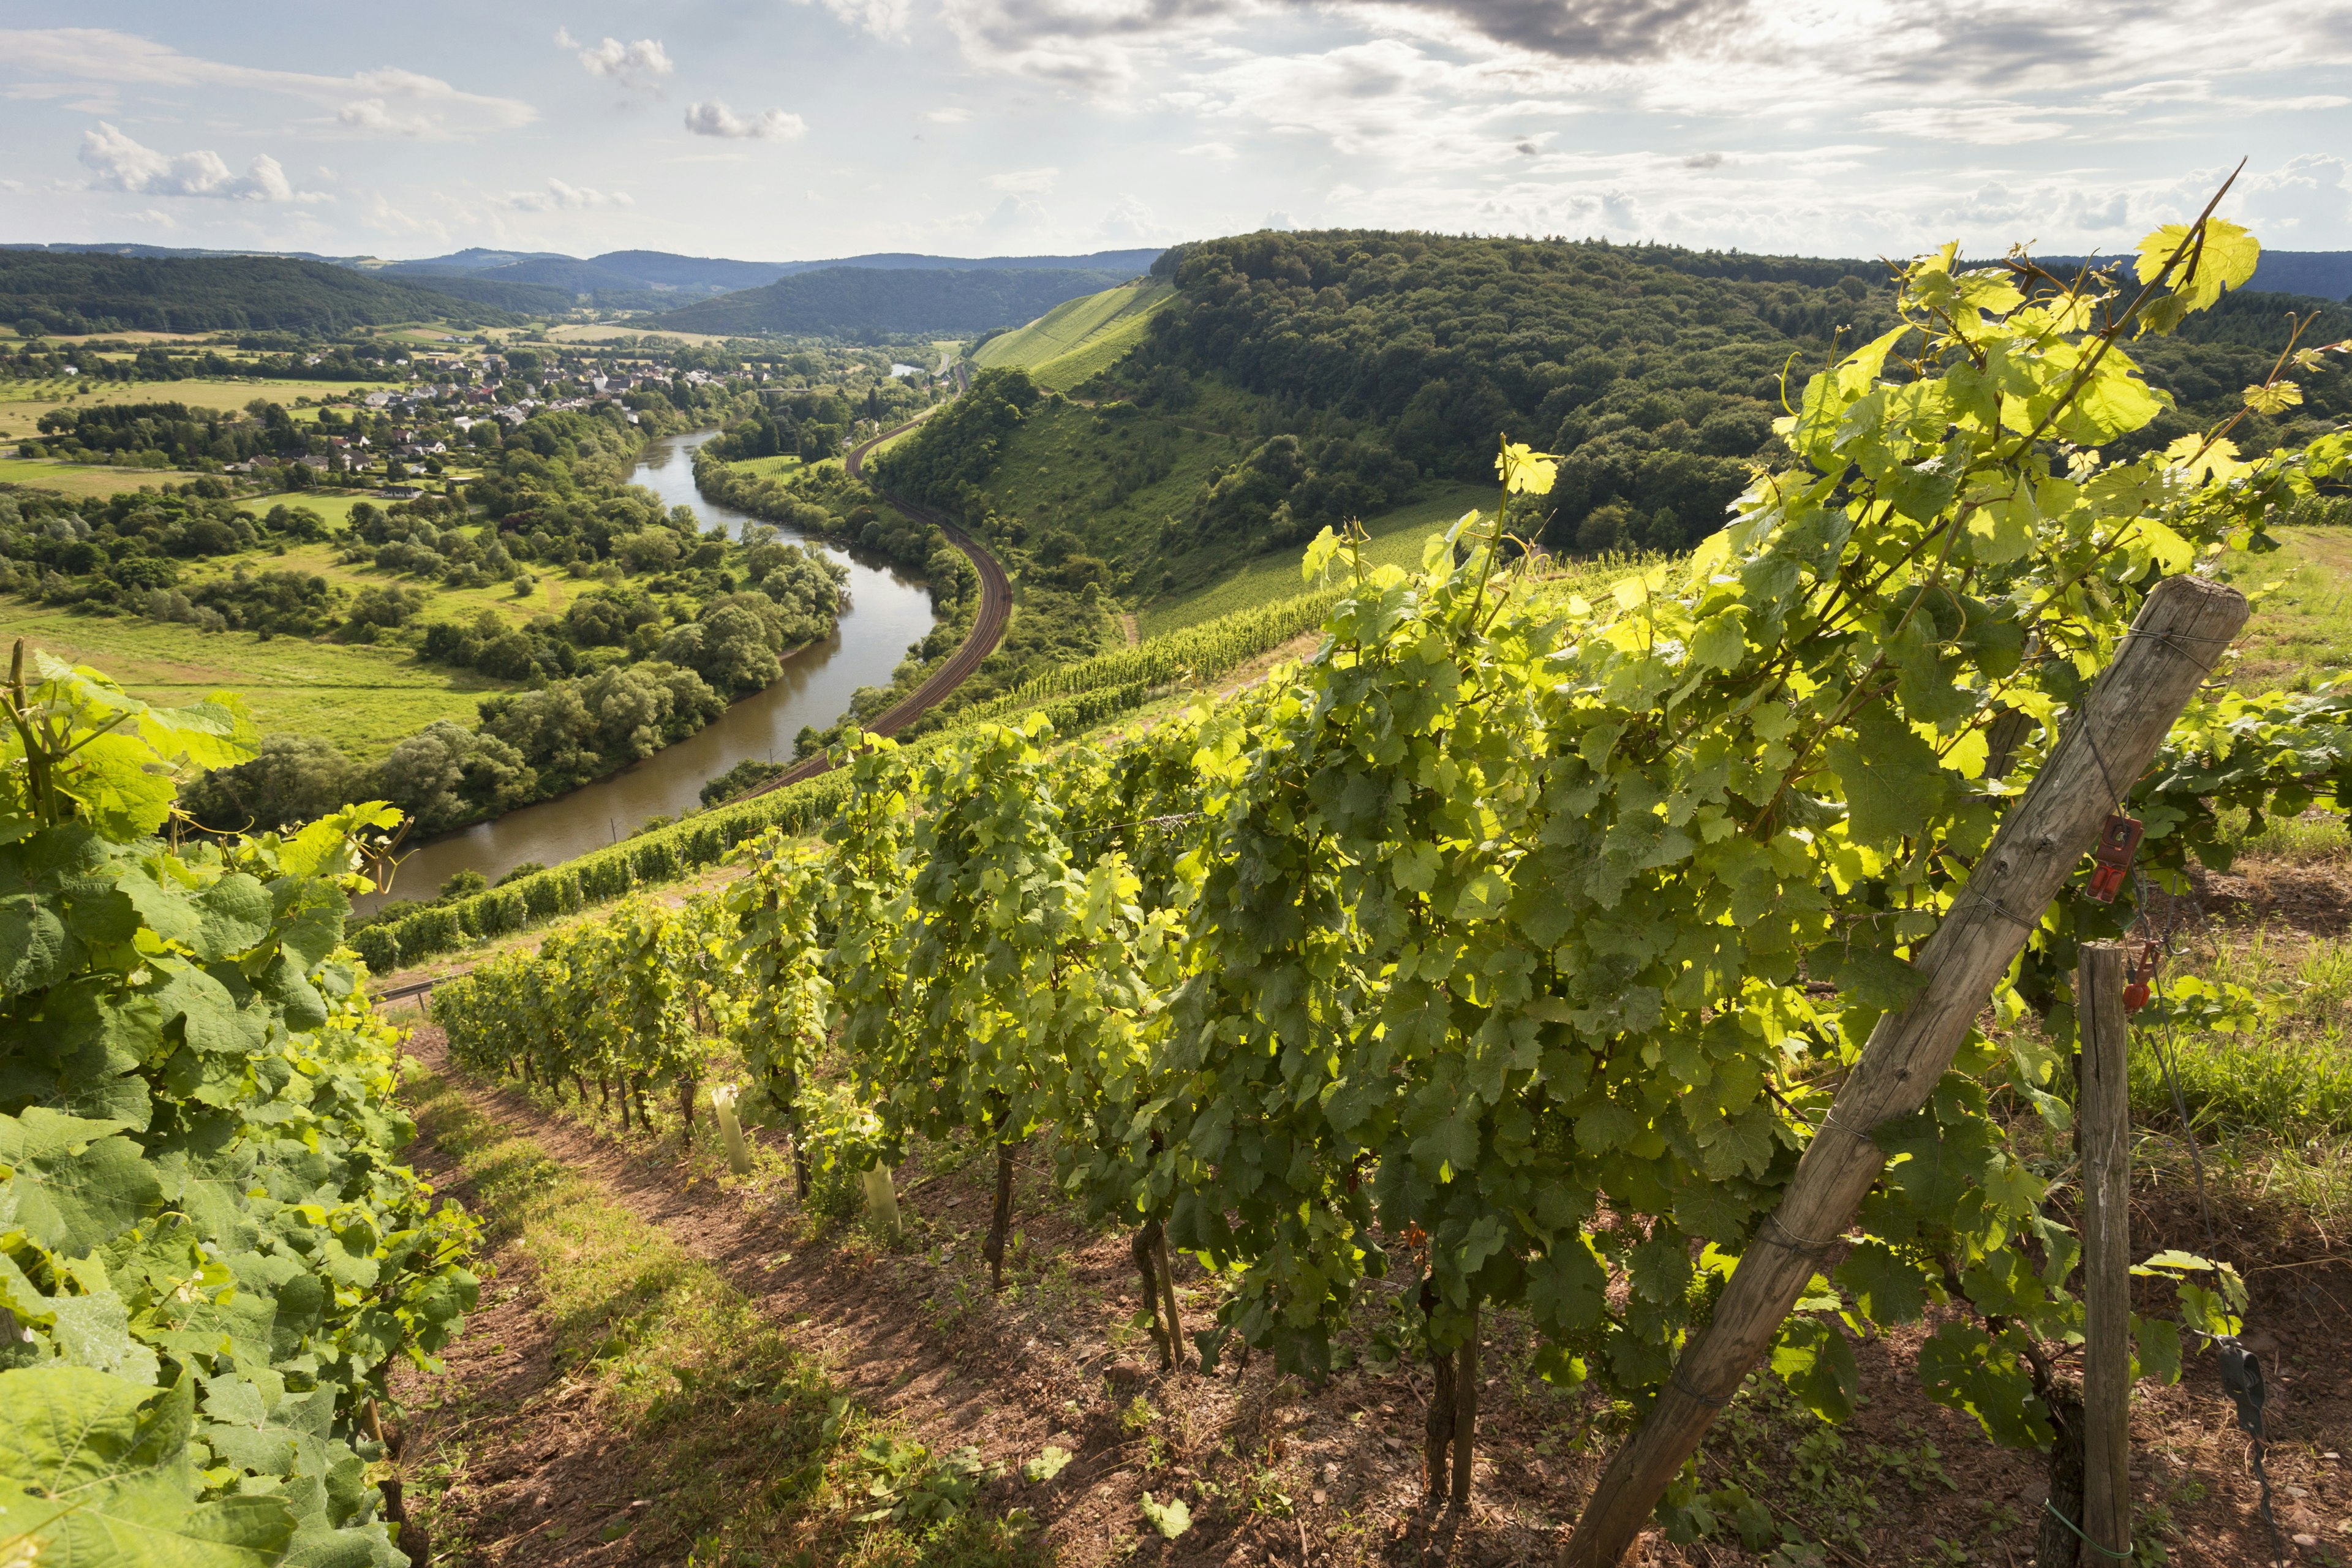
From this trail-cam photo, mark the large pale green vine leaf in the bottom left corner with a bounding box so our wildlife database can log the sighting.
[0,1366,294,1568]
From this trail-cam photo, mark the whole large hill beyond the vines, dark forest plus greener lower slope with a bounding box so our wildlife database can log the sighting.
[882,230,2352,604]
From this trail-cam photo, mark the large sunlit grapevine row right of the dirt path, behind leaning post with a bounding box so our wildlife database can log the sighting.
[418,221,2352,1561]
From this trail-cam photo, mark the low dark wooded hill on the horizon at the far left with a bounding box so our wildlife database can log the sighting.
[0,249,508,331]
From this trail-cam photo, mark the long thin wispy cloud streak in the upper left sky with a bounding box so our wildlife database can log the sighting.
[0,28,538,137]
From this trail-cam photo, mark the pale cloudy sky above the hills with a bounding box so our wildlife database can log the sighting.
[0,0,2352,261]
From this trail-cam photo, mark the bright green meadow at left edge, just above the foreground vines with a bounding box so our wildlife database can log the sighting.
[0,600,506,760]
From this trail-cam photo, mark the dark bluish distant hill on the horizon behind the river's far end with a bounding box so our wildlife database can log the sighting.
[654,266,1129,336]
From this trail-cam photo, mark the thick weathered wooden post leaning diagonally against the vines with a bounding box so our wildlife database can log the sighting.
[1559,576,2246,1568]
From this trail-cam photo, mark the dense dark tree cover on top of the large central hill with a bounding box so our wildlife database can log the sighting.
[1117,233,2347,550]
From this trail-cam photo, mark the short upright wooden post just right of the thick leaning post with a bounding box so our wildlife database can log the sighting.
[2075,943,2131,1554]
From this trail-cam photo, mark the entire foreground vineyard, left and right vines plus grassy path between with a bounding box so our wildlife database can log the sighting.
[13,216,2352,1568]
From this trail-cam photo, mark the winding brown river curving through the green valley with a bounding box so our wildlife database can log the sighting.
[358,430,932,912]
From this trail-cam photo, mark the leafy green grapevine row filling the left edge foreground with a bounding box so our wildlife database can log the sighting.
[0,642,478,1568]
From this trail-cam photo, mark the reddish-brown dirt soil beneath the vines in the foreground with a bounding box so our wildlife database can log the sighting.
[390,1027,2352,1568]
